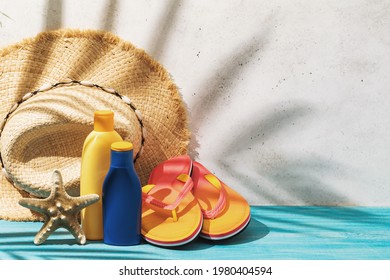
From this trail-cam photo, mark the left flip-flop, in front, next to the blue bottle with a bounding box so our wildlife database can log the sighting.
[141,156,203,247]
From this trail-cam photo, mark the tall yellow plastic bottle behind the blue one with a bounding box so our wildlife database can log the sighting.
[80,110,122,240]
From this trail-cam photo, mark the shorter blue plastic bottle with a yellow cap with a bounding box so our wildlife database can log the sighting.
[103,141,142,245]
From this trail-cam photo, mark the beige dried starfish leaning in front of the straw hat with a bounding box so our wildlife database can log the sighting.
[19,170,99,245]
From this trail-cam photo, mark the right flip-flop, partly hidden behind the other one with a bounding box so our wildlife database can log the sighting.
[191,162,250,240]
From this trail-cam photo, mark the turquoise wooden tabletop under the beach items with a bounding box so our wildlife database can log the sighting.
[0,206,390,260]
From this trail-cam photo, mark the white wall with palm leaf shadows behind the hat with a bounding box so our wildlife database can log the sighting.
[0,0,390,206]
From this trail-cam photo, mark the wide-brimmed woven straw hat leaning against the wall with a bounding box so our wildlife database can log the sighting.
[0,30,189,221]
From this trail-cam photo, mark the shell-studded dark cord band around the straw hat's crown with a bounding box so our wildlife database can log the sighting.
[0,79,146,183]
